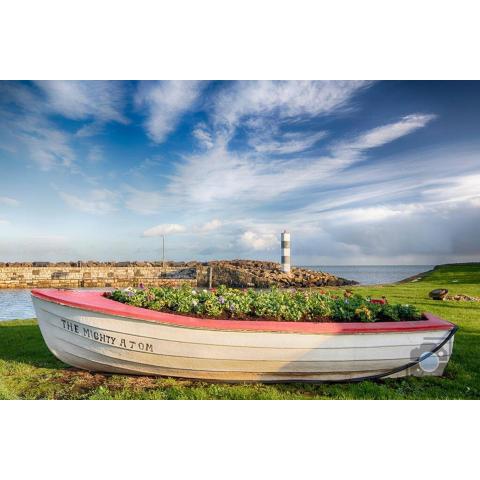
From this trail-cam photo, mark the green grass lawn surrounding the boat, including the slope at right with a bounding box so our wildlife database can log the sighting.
[0,264,480,399]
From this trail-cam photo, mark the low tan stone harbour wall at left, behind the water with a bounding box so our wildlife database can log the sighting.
[0,264,197,289]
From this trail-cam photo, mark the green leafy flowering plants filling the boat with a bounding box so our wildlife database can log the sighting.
[108,285,420,322]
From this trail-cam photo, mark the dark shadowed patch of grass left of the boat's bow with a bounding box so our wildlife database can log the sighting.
[0,320,67,369]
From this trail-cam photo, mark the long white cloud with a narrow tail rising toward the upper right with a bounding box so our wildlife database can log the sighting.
[167,115,433,208]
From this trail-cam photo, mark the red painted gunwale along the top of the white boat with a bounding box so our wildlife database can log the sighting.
[32,289,454,334]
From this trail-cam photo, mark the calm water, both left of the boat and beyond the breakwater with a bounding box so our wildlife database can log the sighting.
[0,265,433,321]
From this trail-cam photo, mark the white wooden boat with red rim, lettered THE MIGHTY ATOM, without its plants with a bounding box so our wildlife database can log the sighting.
[32,289,456,382]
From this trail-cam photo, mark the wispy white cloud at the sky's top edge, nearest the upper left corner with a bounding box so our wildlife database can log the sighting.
[36,80,128,123]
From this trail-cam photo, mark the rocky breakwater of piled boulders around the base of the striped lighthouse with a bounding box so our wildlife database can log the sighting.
[197,260,357,288]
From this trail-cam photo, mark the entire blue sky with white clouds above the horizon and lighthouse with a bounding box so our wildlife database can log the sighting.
[0,81,480,265]
